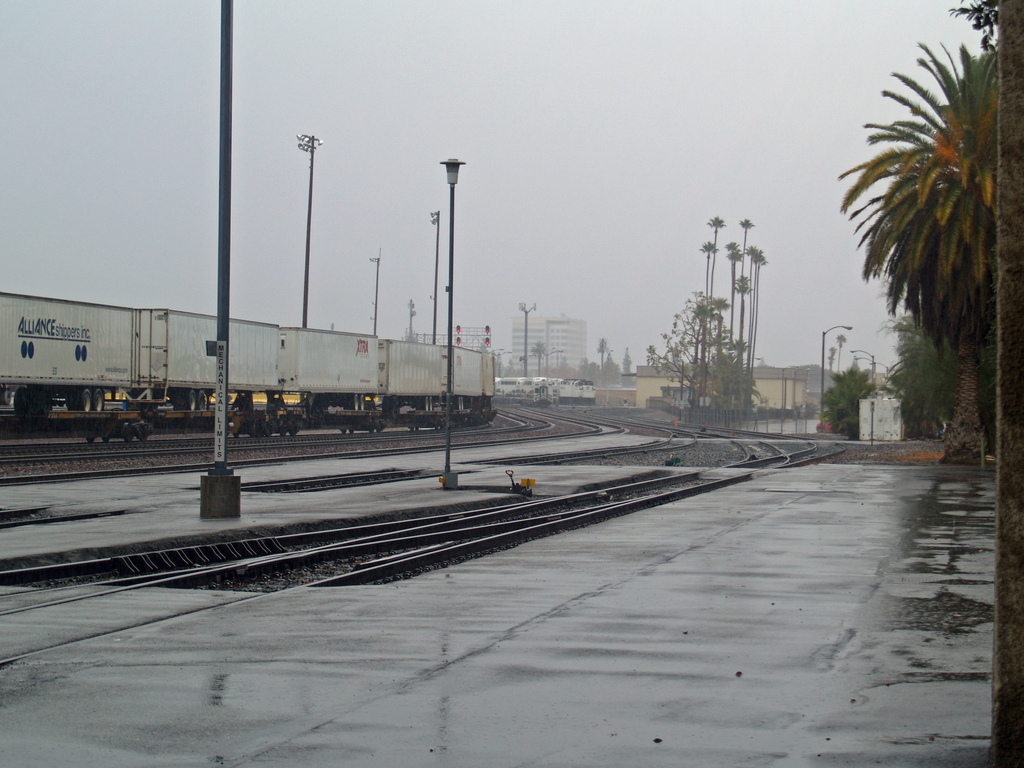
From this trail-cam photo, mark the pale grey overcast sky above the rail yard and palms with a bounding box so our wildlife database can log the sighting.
[0,0,979,367]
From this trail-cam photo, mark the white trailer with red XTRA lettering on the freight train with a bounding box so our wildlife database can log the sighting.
[278,328,378,393]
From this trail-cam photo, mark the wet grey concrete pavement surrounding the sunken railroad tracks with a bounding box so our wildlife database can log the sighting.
[0,435,994,768]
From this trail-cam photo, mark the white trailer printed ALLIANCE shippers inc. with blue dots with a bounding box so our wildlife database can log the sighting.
[0,293,132,387]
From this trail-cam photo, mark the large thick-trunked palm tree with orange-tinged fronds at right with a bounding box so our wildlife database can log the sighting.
[840,45,998,463]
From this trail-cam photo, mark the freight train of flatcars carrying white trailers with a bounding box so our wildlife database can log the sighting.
[0,293,495,438]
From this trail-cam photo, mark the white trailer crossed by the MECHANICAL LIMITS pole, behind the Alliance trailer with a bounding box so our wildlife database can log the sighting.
[133,309,280,391]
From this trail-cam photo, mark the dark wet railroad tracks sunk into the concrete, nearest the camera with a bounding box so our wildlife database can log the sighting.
[0,415,831,666]
